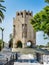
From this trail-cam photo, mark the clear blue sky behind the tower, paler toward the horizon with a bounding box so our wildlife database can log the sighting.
[0,0,48,44]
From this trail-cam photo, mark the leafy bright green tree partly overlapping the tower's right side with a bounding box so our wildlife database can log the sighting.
[31,6,49,36]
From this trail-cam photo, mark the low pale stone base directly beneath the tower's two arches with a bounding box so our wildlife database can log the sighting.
[12,48,36,54]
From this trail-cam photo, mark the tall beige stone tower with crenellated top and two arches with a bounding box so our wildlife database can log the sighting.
[13,10,36,48]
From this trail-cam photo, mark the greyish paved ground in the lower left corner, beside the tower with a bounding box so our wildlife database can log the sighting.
[0,48,12,65]
